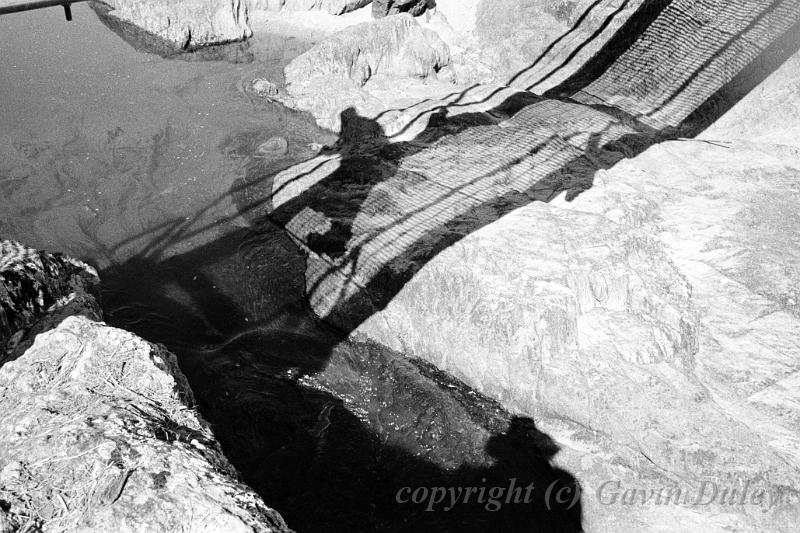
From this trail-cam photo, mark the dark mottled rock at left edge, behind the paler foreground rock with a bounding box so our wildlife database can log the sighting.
[0,240,100,364]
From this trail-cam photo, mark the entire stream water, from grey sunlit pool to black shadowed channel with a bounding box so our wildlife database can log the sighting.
[0,4,580,531]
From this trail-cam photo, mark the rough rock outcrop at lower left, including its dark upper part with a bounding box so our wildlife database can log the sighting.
[0,241,289,532]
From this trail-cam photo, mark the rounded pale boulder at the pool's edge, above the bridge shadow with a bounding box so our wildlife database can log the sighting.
[285,14,450,130]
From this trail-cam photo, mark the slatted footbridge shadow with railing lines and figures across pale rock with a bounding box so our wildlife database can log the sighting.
[255,0,800,331]
